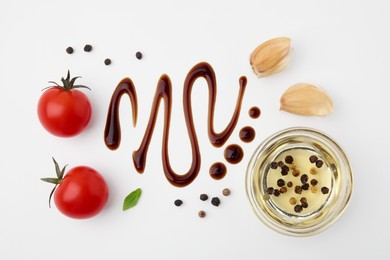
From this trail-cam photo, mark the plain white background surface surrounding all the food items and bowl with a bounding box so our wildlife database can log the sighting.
[0,0,390,259]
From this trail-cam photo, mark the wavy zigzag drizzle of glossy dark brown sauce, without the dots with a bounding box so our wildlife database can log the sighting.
[105,62,247,187]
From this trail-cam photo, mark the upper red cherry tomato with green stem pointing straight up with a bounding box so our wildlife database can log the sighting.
[38,71,92,137]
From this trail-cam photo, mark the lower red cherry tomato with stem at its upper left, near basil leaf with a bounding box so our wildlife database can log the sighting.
[41,158,109,219]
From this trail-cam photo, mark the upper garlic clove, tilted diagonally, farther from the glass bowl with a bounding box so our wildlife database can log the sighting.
[250,37,291,78]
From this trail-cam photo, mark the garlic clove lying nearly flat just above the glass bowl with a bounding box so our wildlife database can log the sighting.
[280,83,333,116]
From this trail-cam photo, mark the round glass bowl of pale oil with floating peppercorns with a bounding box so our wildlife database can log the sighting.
[246,127,353,236]
